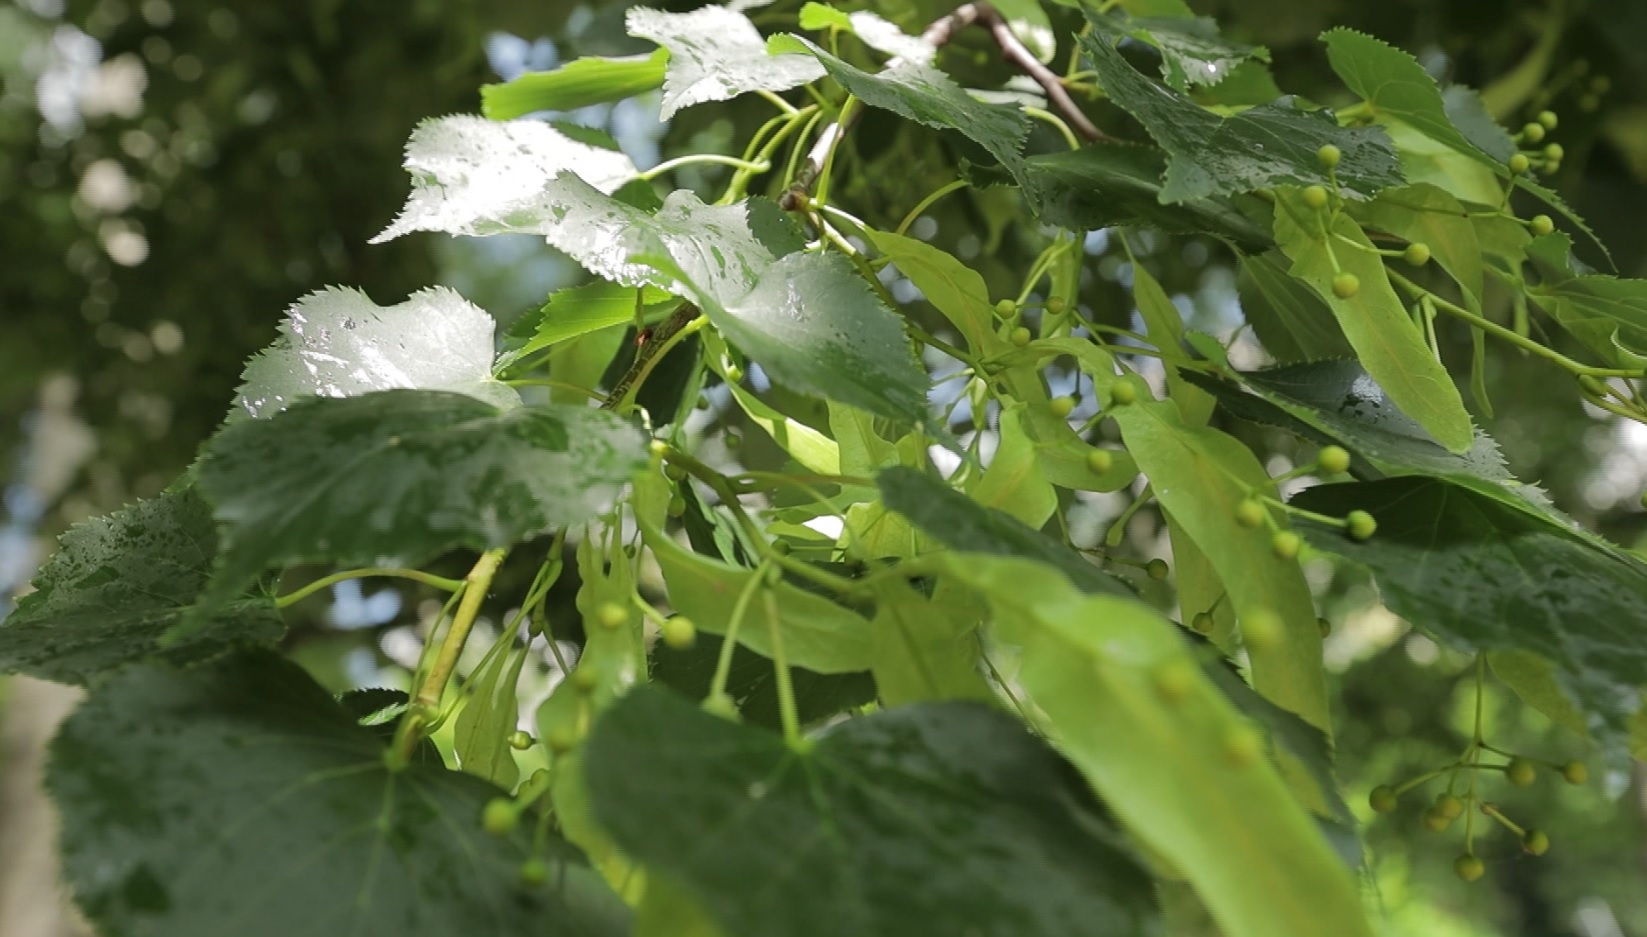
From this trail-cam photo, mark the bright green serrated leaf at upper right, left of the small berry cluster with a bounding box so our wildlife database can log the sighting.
[1321,28,1507,167]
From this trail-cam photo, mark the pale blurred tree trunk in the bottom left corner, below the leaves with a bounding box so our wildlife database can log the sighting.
[0,677,91,937]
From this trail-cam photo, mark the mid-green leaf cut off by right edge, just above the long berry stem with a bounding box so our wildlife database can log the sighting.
[1527,234,1647,369]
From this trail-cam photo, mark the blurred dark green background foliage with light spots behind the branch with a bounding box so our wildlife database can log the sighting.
[0,0,1647,937]
